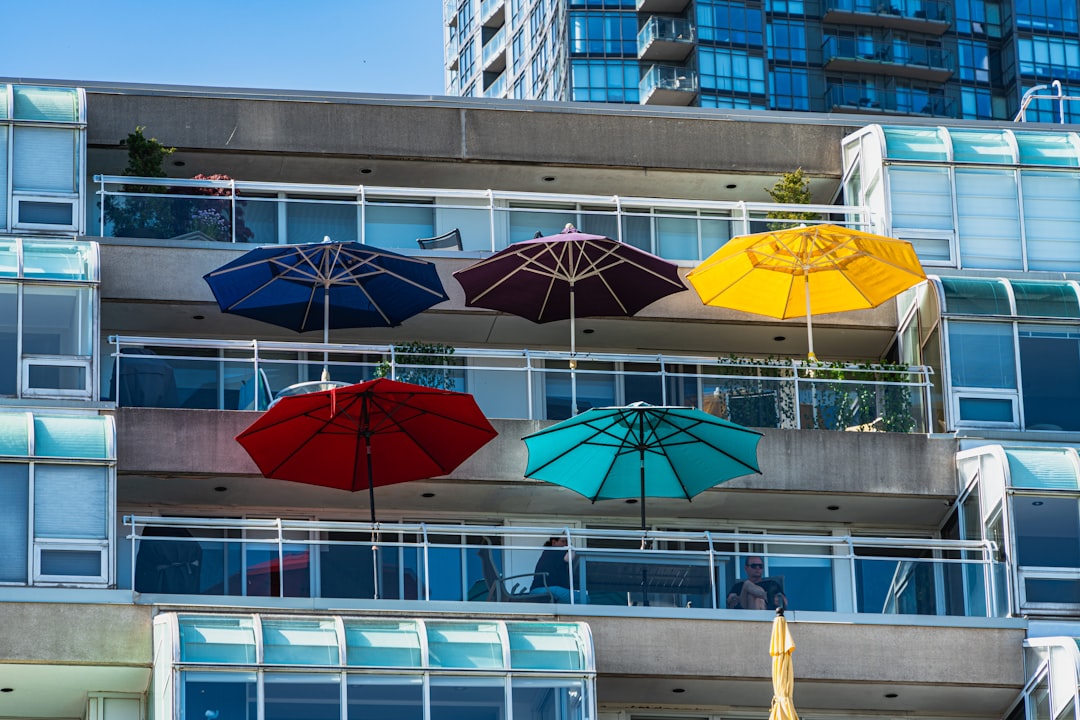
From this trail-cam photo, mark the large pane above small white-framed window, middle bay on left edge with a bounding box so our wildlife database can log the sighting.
[23,286,93,355]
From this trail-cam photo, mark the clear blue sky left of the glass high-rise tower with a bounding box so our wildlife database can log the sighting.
[0,0,443,95]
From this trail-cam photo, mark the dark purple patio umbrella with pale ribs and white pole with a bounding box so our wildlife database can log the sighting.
[454,225,687,415]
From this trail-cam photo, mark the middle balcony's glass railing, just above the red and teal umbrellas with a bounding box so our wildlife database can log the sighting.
[111,336,931,433]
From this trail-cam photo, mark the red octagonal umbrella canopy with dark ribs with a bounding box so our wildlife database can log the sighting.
[237,378,498,522]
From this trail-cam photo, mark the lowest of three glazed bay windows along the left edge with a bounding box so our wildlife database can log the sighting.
[0,411,116,585]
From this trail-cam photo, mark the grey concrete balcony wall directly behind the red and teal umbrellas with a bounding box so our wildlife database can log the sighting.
[117,408,957,530]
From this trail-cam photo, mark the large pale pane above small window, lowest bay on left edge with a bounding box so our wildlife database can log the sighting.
[33,463,109,537]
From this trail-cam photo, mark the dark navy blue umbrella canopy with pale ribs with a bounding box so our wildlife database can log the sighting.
[203,239,447,342]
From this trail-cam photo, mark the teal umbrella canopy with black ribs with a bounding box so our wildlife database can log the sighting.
[524,403,761,530]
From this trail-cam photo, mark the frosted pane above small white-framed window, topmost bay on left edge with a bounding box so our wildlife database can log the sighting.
[12,127,78,193]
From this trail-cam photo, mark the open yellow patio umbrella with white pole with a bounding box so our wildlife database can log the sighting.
[687,225,927,359]
